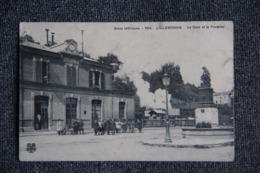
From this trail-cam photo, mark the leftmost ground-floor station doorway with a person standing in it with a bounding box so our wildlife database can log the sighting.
[34,96,49,130]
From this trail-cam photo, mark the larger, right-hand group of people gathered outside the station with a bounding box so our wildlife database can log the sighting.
[94,119,142,136]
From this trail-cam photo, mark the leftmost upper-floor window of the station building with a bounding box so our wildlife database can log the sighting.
[36,60,50,83]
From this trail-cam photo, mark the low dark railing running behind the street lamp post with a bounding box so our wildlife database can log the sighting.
[143,119,195,127]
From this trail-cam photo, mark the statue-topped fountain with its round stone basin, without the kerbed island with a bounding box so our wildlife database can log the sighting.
[182,67,233,139]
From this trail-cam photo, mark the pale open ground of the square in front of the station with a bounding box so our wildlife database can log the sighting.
[19,127,234,161]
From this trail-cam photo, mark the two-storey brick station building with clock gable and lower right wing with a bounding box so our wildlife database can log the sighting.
[19,36,135,131]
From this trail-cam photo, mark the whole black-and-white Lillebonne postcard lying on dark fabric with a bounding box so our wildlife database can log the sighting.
[19,21,234,161]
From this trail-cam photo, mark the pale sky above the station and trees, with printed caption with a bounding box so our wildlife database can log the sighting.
[20,22,234,108]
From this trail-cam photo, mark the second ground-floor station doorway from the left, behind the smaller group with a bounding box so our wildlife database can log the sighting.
[66,98,77,127]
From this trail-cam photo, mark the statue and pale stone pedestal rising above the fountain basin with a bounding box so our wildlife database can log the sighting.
[195,67,218,127]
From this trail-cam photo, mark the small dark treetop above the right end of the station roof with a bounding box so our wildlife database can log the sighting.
[98,53,123,73]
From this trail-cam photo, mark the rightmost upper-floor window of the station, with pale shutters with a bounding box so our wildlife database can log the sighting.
[89,71,105,89]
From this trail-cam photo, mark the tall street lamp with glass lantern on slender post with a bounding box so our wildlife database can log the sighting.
[162,73,172,143]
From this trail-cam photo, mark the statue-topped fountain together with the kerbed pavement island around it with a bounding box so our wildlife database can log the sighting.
[142,67,234,148]
